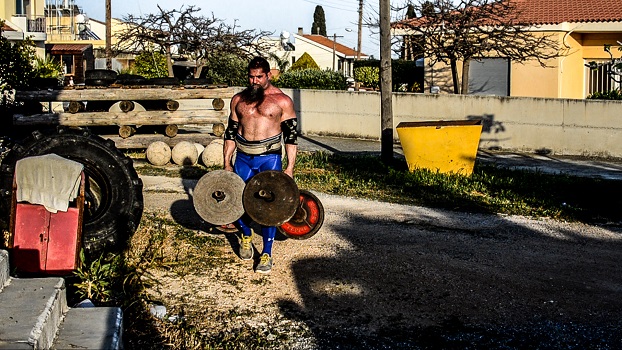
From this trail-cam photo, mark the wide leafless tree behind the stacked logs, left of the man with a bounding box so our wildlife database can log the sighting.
[115,6,271,78]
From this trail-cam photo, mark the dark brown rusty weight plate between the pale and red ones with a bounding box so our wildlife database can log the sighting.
[242,170,300,226]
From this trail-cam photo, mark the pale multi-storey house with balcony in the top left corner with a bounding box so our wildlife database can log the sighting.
[0,0,47,57]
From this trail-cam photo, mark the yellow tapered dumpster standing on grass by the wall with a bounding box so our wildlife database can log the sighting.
[397,120,482,176]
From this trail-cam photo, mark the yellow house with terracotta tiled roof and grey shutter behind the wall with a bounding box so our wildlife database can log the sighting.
[392,0,622,99]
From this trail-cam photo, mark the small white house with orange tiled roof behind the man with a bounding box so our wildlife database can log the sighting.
[271,28,369,77]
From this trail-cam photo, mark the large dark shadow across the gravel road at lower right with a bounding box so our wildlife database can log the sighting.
[280,204,622,349]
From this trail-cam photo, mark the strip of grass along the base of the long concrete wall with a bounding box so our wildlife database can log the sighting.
[138,152,622,223]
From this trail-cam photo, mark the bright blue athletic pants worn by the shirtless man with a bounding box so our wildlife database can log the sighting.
[233,152,283,256]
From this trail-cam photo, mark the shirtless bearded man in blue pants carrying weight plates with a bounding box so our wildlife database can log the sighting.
[223,57,298,273]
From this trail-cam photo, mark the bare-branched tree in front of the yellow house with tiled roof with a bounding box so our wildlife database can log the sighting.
[393,0,563,94]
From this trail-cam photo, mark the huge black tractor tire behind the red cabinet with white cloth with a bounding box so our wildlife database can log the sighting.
[2,128,143,256]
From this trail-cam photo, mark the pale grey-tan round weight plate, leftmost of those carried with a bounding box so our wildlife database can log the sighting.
[192,170,245,225]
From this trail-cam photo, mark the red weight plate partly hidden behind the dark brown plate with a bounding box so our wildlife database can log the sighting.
[278,190,324,239]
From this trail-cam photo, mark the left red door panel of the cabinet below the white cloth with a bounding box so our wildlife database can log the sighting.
[11,203,50,272]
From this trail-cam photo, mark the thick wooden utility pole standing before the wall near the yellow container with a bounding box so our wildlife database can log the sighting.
[380,0,393,164]
